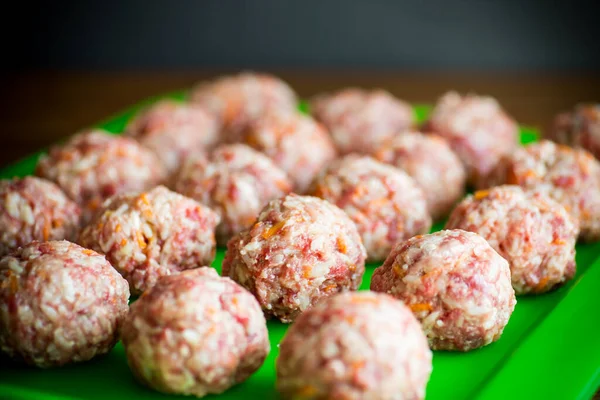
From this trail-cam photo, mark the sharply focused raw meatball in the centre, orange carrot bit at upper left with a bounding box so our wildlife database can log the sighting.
[223,194,366,322]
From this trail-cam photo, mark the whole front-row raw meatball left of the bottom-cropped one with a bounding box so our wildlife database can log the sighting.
[122,268,270,397]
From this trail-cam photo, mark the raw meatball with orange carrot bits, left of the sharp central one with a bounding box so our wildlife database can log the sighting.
[79,186,219,294]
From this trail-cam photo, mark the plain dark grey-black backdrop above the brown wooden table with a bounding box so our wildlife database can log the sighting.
[7,0,600,72]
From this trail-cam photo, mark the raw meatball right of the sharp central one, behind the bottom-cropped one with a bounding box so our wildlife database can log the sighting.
[371,229,516,351]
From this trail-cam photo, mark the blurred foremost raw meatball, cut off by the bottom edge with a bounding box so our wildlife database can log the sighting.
[277,292,431,400]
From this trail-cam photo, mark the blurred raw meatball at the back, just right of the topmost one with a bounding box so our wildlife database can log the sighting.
[311,88,414,154]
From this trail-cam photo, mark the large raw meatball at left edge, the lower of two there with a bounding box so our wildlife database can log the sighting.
[0,241,129,368]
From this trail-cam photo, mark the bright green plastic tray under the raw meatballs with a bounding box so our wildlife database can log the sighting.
[0,92,600,400]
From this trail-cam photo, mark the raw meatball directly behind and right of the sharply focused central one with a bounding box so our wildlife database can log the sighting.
[311,155,431,262]
